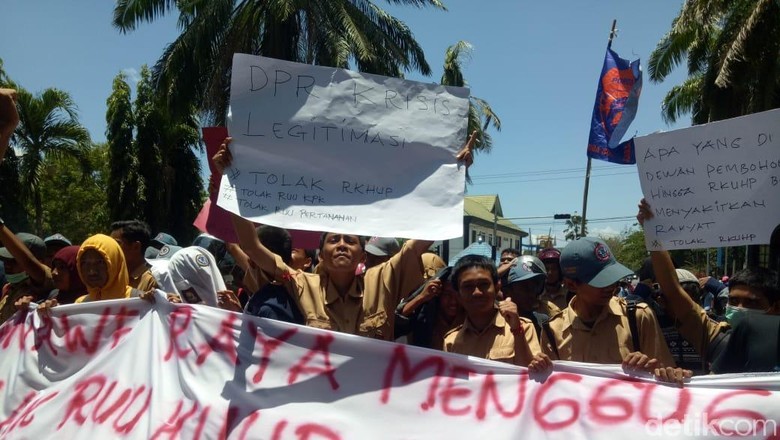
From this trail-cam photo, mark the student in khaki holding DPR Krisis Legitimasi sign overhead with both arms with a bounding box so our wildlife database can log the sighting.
[213,136,476,341]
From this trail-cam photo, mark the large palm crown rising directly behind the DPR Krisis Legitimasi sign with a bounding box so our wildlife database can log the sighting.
[113,0,444,124]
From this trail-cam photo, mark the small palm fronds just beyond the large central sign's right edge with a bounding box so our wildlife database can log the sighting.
[441,41,501,156]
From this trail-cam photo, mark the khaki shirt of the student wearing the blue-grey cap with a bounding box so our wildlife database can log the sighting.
[542,296,675,367]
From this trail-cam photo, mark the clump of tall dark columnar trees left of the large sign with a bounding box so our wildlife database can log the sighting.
[106,66,203,242]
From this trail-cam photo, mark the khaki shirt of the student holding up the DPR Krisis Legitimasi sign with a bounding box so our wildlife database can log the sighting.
[274,241,423,341]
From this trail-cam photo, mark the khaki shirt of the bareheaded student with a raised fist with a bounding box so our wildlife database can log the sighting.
[444,311,542,366]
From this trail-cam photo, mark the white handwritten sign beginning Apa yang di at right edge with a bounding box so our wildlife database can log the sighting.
[635,110,780,250]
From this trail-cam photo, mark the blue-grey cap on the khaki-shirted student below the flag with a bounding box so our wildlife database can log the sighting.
[561,237,634,288]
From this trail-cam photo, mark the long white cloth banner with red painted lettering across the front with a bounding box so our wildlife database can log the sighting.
[0,293,780,440]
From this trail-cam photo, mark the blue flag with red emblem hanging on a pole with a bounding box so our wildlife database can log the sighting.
[588,48,642,164]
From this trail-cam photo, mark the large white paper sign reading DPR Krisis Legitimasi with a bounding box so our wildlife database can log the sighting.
[218,54,468,239]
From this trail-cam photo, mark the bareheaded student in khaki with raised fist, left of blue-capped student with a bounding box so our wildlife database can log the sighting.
[444,255,551,369]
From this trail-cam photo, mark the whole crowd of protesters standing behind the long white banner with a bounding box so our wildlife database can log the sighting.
[0,89,780,383]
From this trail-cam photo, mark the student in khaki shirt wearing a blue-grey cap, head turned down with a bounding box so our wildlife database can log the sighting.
[542,237,675,372]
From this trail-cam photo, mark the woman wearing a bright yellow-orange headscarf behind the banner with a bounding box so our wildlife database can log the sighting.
[76,234,133,303]
